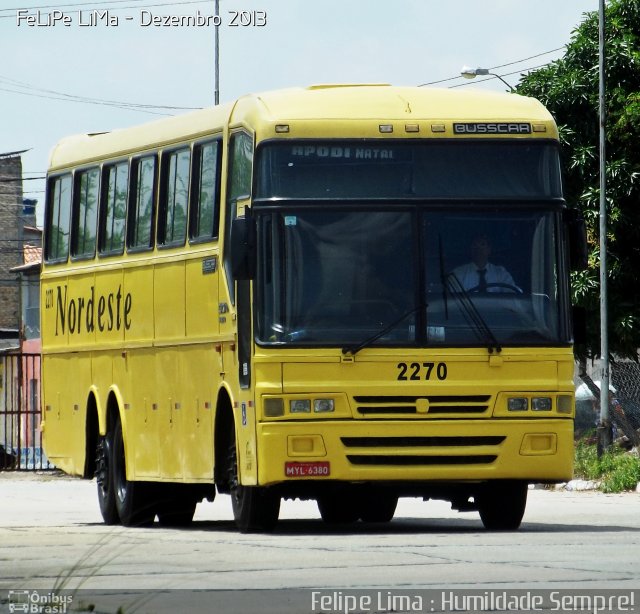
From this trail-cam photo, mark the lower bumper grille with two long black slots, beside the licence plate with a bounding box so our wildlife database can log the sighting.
[341,435,506,467]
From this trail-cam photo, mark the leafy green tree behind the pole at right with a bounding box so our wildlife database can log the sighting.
[517,0,640,358]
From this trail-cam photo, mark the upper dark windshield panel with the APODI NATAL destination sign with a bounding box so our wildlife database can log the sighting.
[256,139,561,199]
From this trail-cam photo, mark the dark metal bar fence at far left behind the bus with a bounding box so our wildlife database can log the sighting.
[0,353,54,471]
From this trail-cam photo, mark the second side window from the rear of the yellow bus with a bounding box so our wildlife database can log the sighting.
[71,167,100,259]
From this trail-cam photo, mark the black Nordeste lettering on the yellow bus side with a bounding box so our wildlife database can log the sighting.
[55,285,133,337]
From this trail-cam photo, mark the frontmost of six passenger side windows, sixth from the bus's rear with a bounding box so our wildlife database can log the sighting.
[189,140,222,242]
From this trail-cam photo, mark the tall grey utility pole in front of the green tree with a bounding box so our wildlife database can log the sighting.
[598,0,613,456]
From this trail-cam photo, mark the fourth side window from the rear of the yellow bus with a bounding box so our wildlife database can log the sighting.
[127,155,157,251]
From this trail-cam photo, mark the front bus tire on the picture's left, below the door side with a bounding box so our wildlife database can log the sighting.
[227,424,280,533]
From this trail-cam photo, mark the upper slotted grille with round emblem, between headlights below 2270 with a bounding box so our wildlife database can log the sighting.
[354,395,491,418]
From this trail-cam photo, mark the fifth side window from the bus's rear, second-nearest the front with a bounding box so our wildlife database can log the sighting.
[158,147,191,247]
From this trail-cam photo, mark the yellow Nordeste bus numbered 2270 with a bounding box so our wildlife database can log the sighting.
[41,85,583,531]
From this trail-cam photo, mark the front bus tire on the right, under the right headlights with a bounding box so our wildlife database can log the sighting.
[477,481,528,531]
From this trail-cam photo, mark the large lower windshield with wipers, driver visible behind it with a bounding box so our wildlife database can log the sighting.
[256,208,570,348]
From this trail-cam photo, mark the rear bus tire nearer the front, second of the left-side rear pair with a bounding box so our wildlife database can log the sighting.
[113,418,156,527]
